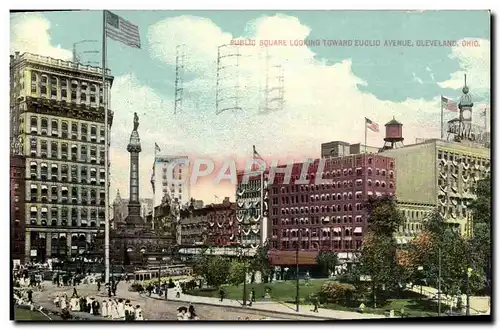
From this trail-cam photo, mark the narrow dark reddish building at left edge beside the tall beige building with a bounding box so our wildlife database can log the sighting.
[10,154,26,263]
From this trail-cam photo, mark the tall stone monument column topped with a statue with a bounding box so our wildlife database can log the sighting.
[125,113,142,227]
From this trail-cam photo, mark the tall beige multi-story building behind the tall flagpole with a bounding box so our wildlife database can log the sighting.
[10,53,113,261]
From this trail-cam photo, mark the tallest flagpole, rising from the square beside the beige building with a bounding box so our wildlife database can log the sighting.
[102,10,109,283]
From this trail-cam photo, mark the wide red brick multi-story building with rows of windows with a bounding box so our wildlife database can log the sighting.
[268,154,396,265]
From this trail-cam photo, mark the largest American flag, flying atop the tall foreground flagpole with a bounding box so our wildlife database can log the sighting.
[104,10,141,48]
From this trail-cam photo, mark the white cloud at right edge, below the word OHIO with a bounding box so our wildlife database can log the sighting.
[438,38,491,94]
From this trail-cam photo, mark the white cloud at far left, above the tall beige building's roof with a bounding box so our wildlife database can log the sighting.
[10,13,72,60]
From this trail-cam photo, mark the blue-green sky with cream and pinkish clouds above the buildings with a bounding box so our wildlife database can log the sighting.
[10,10,490,203]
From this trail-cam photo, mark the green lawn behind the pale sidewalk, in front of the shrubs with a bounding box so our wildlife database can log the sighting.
[186,280,327,302]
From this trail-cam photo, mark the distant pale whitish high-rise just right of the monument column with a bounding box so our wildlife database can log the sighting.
[154,155,191,205]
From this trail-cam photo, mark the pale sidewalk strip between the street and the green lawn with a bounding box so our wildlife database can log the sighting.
[143,290,385,320]
